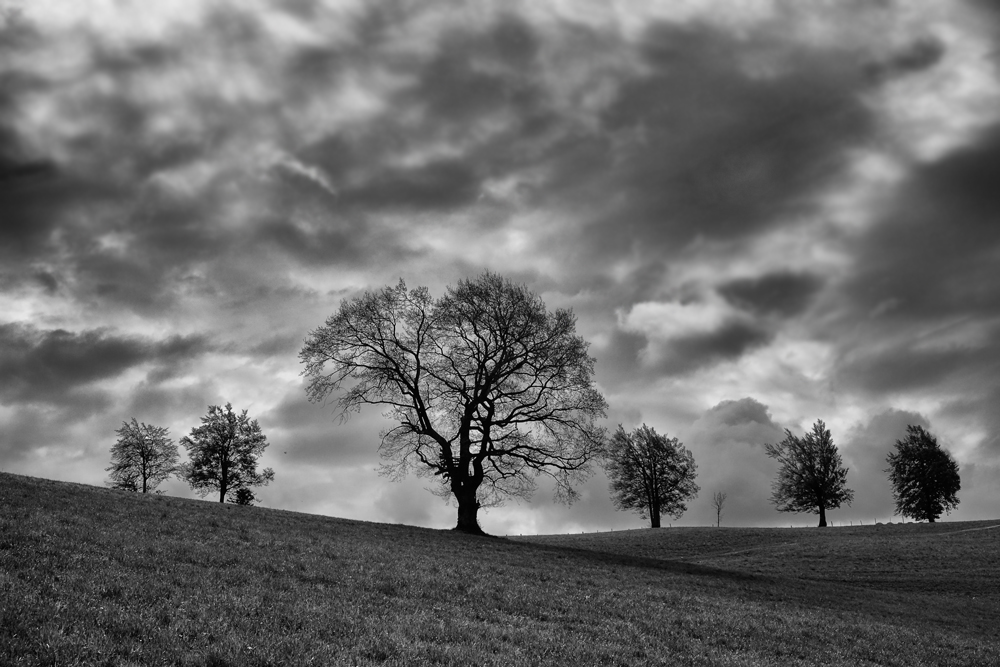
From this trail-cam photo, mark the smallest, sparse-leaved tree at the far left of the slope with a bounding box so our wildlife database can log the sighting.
[105,417,178,493]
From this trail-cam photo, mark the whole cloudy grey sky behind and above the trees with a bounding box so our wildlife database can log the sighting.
[0,0,1000,534]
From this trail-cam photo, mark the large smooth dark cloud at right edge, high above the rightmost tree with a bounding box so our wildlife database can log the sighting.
[847,127,1000,323]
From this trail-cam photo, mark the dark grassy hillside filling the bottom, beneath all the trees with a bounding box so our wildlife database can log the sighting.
[0,474,1000,667]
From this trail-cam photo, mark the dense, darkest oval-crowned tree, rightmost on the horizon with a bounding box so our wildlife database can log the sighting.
[885,426,962,523]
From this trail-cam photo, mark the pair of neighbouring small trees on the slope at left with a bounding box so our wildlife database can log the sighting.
[106,403,274,505]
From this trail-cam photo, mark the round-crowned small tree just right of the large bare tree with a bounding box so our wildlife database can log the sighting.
[604,424,698,528]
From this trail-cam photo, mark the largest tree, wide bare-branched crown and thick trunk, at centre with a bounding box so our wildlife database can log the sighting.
[299,272,607,533]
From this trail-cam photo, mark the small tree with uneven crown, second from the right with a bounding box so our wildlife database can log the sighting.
[764,420,854,528]
